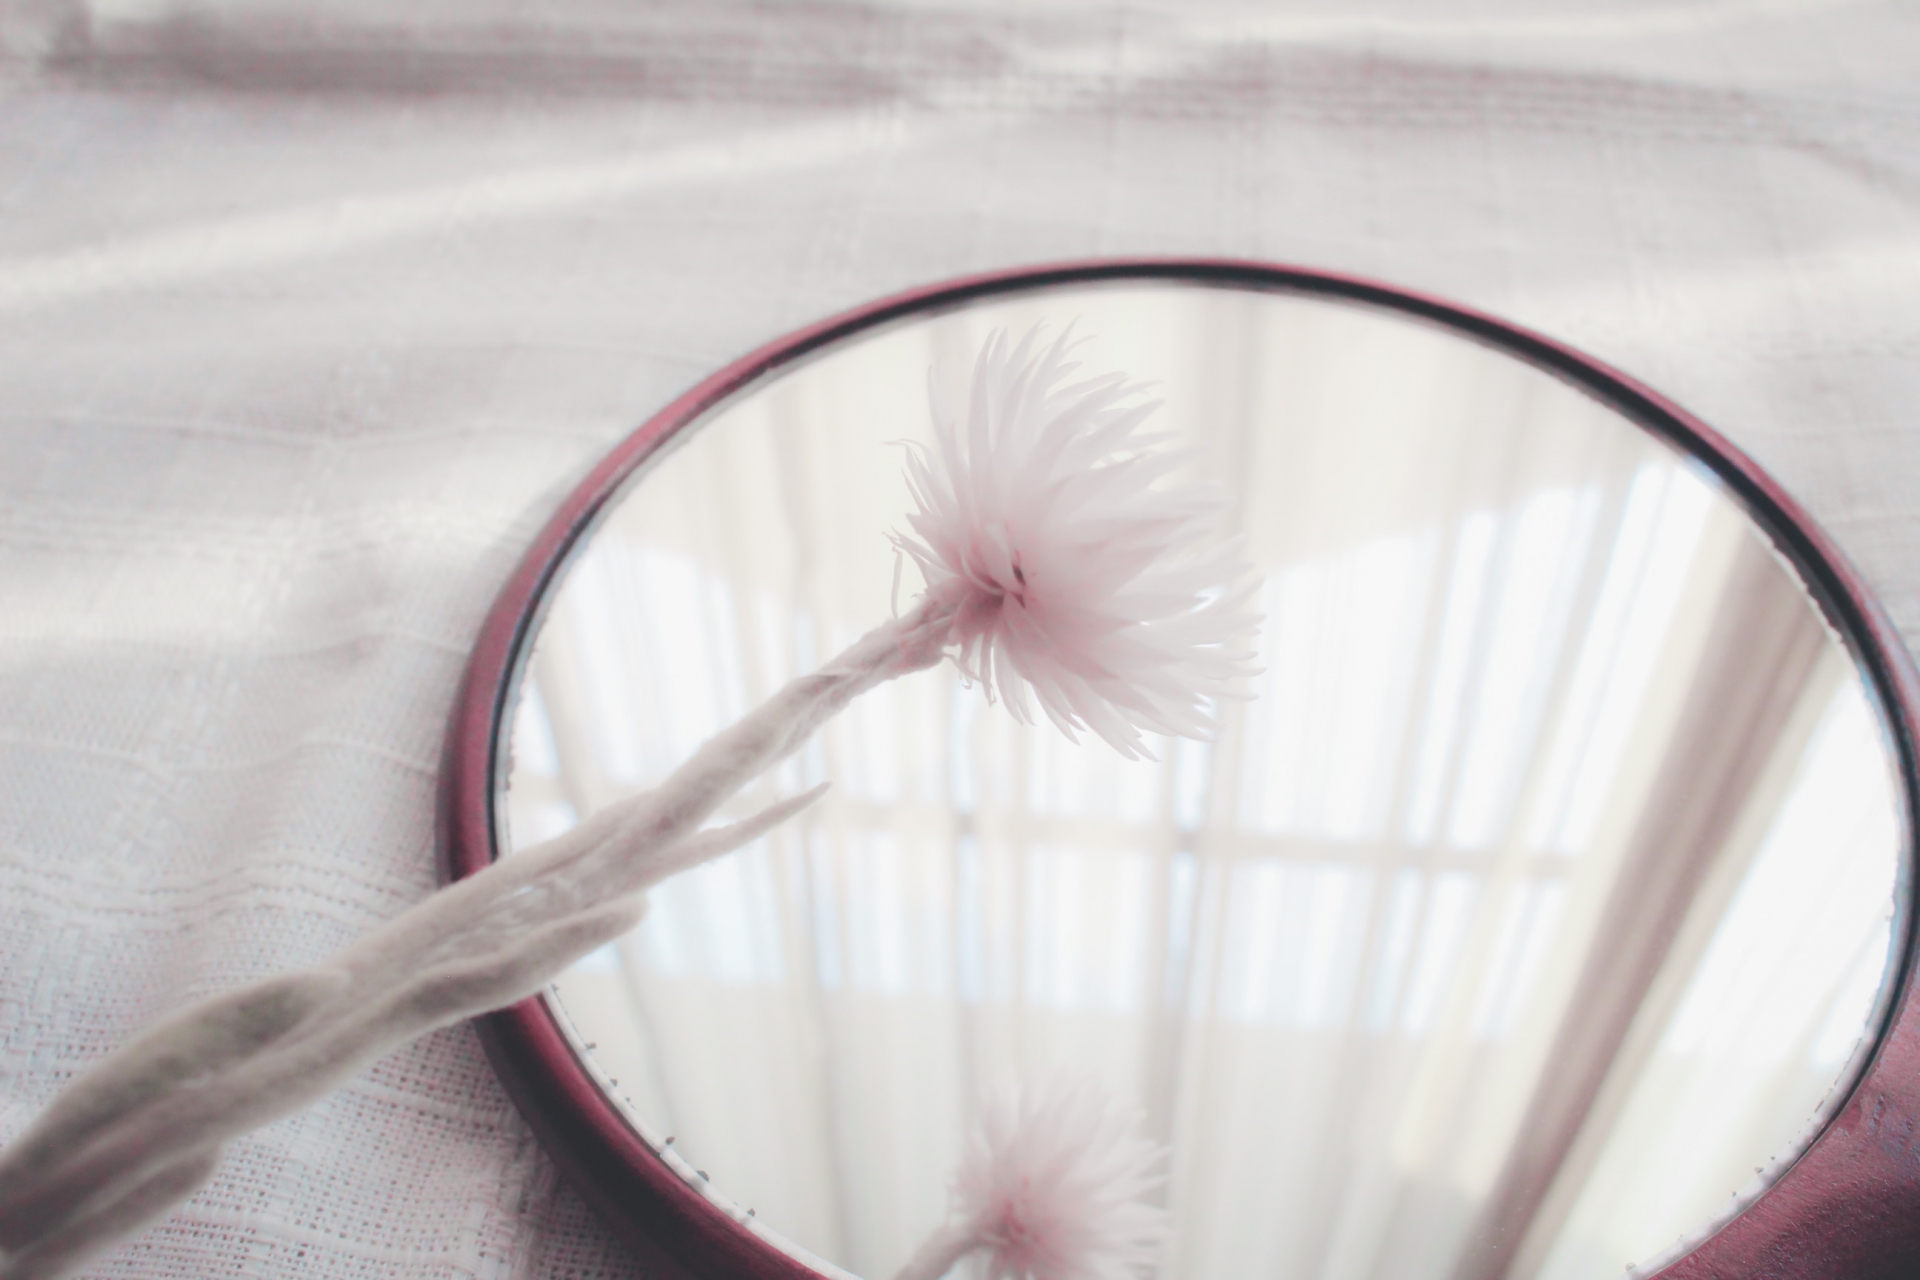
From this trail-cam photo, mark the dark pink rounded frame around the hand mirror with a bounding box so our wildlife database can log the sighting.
[438,259,1920,1280]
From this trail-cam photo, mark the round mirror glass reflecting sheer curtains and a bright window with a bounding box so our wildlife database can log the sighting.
[497,282,1903,1280]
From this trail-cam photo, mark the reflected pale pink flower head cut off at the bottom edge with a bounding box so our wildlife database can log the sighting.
[952,1082,1167,1280]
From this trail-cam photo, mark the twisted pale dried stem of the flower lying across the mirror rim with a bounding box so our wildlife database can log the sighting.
[0,604,952,1280]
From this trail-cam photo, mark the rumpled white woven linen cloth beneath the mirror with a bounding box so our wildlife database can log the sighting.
[0,0,1920,1278]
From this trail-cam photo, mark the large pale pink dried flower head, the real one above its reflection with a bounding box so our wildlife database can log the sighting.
[893,330,1260,756]
